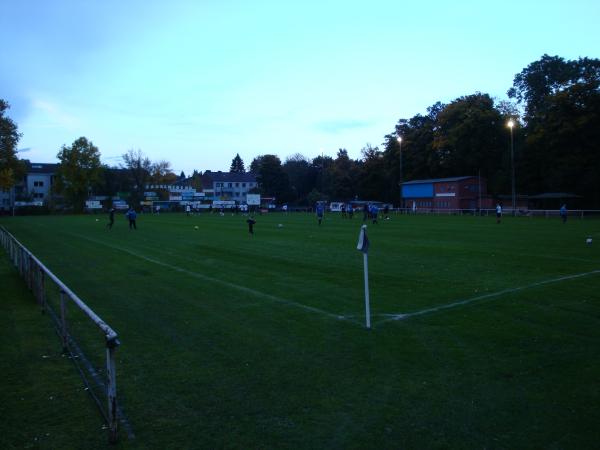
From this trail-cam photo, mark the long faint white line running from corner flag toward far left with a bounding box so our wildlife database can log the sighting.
[69,233,362,325]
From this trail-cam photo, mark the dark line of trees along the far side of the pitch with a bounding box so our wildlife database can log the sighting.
[0,55,600,207]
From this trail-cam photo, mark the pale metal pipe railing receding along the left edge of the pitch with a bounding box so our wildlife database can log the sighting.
[0,227,120,443]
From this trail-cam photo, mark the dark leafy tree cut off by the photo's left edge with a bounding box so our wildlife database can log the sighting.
[0,99,25,204]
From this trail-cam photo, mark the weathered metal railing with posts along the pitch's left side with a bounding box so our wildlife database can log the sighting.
[0,227,123,443]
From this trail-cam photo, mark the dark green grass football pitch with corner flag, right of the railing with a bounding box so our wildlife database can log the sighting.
[0,213,600,449]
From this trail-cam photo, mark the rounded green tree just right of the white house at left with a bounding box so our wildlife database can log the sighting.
[56,137,101,212]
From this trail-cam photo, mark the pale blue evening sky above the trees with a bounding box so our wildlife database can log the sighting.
[0,0,600,175]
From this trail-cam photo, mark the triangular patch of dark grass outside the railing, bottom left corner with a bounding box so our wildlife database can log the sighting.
[0,241,106,449]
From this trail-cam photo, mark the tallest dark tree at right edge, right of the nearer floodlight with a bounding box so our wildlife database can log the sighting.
[508,55,600,207]
